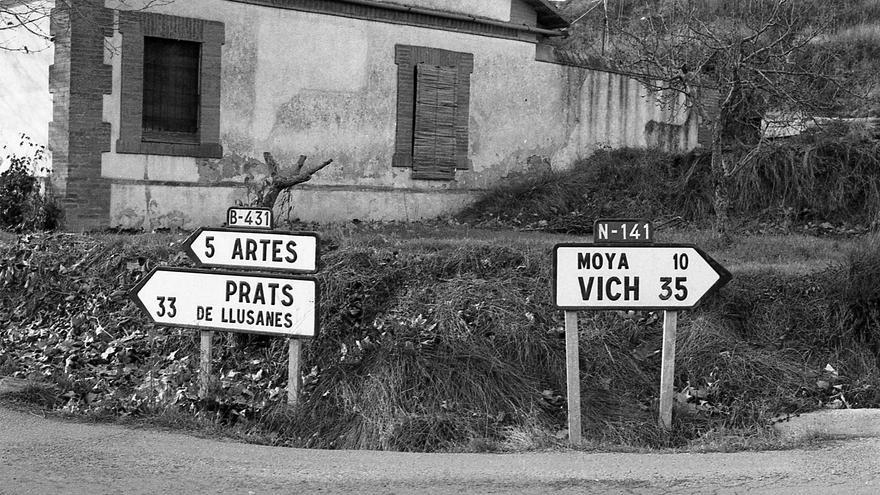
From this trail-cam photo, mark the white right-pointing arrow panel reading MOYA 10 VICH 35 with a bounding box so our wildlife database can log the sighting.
[553,244,731,310]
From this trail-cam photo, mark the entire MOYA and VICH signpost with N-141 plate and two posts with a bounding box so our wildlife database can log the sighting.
[553,219,731,445]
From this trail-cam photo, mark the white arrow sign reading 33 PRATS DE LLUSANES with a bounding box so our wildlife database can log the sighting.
[130,267,318,337]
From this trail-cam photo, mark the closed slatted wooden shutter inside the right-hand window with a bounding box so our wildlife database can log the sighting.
[412,64,459,180]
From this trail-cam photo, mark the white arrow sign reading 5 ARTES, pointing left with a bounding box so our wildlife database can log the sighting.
[184,228,318,273]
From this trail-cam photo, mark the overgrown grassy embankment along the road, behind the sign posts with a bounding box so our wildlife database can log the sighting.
[0,140,880,451]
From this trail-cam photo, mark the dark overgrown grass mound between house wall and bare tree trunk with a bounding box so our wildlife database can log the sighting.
[458,149,712,233]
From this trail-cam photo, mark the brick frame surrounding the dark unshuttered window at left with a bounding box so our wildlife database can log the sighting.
[116,11,225,158]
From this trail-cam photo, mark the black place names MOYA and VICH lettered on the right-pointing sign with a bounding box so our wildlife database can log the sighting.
[578,252,639,301]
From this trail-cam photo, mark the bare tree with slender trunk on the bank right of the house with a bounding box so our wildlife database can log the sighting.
[564,0,864,238]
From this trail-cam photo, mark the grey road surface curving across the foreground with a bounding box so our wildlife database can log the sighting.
[0,408,880,495]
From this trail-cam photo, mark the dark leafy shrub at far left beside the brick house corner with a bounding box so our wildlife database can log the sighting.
[0,135,62,232]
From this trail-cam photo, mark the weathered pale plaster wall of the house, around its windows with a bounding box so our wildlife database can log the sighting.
[41,0,696,229]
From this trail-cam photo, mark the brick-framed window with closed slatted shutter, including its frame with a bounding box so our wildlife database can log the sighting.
[392,45,473,180]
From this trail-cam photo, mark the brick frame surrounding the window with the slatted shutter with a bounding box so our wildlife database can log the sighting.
[392,45,474,180]
